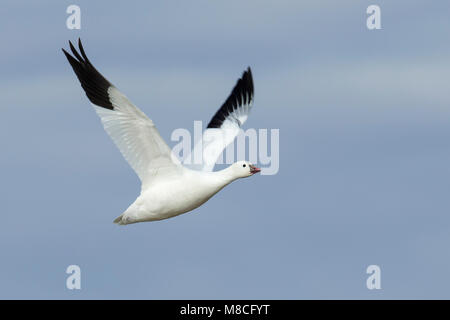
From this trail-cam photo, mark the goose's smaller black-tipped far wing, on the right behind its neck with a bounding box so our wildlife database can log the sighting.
[184,67,254,171]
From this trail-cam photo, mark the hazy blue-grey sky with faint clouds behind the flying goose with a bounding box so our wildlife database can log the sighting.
[0,0,450,299]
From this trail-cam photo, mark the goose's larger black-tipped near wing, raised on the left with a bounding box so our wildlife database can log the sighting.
[62,39,180,183]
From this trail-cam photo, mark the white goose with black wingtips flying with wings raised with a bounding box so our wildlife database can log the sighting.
[62,39,260,225]
